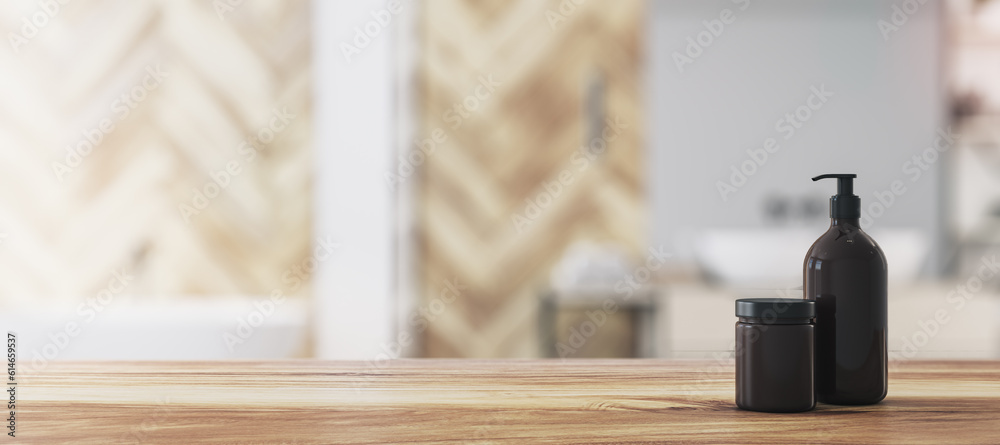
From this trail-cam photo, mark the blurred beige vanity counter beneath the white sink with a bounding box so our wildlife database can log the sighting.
[656,280,1000,361]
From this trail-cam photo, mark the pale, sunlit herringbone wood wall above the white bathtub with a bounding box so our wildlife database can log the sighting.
[0,0,312,301]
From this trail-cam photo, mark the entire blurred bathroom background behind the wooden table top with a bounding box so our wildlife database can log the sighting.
[0,0,1000,362]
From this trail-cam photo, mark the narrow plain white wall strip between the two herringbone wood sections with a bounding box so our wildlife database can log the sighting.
[313,0,402,360]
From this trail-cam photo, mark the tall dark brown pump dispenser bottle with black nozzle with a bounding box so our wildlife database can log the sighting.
[803,174,888,405]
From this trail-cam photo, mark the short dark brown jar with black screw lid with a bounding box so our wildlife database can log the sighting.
[735,298,816,413]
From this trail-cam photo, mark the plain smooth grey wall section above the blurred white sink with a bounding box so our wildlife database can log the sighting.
[647,0,946,270]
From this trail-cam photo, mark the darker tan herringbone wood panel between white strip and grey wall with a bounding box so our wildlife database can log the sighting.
[417,0,645,357]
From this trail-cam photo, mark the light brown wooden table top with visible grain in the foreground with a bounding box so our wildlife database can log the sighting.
[17,360,1000,444]
